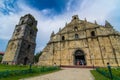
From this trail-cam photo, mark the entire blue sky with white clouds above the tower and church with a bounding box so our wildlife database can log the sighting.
[0,0,120,53]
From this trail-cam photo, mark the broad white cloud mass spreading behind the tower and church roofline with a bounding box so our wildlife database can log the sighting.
[0,0,120,52]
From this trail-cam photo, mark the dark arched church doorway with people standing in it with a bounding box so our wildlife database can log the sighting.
[74,50,86,65]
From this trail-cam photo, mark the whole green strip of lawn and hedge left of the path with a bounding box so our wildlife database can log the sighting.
[0,65,60,80]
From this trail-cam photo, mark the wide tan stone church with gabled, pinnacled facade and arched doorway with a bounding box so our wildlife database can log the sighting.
[38,15,120,66]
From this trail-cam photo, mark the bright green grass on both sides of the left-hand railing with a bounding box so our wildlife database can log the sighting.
[0,64,60,80]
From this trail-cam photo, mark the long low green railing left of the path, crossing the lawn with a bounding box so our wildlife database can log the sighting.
[0,66,60,78]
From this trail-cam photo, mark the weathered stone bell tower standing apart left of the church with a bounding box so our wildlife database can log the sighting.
[2,14,37,65]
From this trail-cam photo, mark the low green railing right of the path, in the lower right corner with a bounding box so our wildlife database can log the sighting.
[96,68,120,80]
